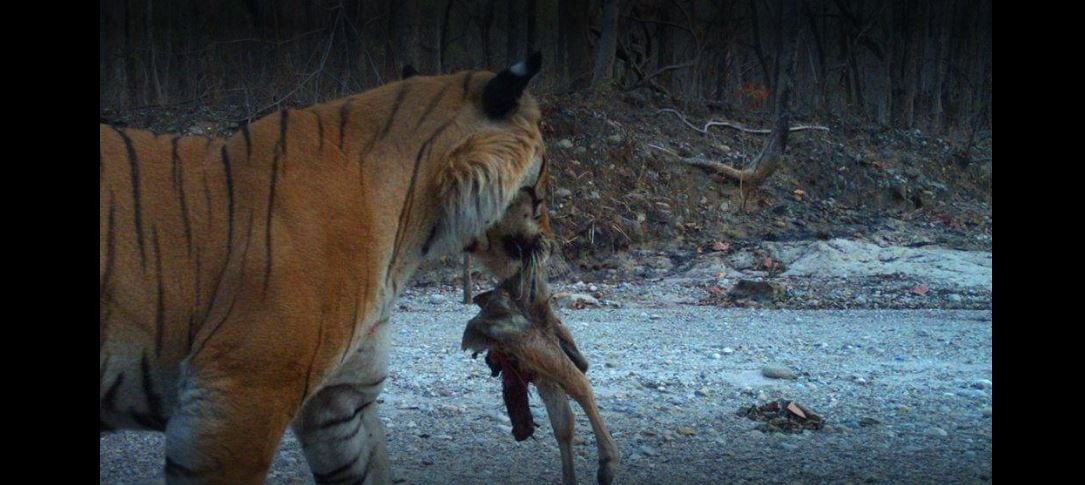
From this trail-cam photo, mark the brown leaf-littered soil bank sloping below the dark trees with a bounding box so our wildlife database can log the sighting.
[533,94,992,275]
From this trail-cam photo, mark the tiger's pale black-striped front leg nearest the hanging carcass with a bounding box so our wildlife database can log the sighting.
[293,320,392,484]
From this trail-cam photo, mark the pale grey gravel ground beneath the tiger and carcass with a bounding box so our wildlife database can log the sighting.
[99,291,993,484]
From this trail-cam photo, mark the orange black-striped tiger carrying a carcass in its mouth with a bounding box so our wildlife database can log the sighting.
[99,52,552,484]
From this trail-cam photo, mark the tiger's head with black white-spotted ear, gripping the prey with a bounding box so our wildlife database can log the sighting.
[404,52,553,299]
